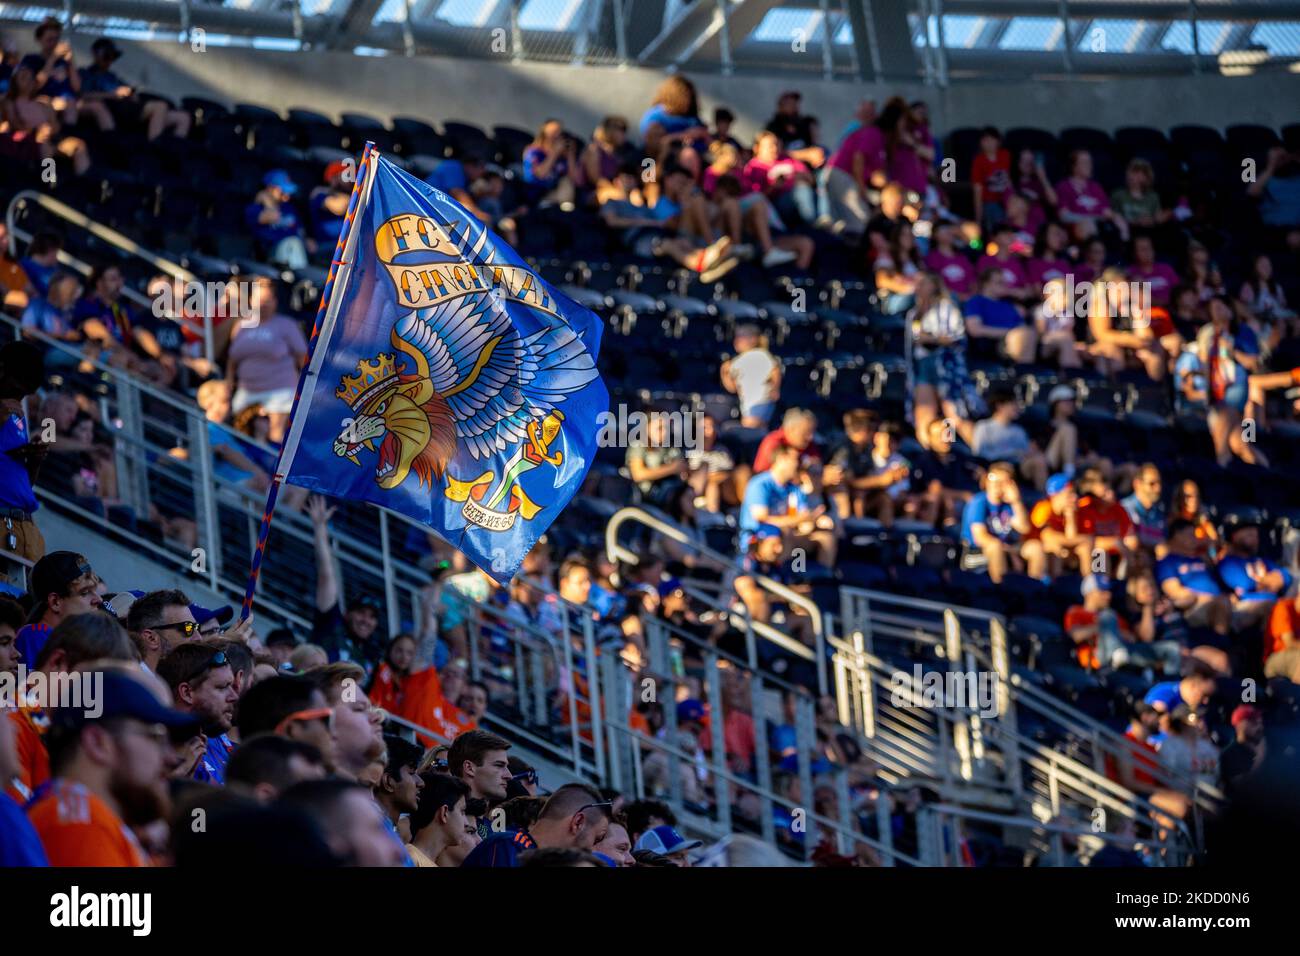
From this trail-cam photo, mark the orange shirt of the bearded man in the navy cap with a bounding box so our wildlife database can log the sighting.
[27,780,150,866]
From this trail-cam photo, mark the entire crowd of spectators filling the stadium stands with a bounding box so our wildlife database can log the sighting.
[0,21,1300,865]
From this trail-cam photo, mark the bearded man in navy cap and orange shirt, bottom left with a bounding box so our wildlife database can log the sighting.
[27,665,195,866]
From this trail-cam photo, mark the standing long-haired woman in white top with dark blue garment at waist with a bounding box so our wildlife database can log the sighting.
[907,272,983,444]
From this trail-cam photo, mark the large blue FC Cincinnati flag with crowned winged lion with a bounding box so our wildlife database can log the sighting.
[280,151,610,581]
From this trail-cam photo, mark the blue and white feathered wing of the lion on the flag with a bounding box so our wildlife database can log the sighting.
[394,293,598,459]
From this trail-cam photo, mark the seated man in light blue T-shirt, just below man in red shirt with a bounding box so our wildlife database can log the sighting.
[740,442,836,567]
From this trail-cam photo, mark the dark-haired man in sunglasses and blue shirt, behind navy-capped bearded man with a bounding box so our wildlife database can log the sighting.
[157,641,239,787]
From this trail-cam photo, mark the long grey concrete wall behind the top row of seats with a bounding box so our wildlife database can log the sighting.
[75,38,1300,139]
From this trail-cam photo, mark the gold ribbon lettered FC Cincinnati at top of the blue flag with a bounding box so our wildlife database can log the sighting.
[374,213,558,316]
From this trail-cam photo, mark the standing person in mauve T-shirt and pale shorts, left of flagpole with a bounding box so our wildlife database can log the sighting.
[226,277,307,444]
